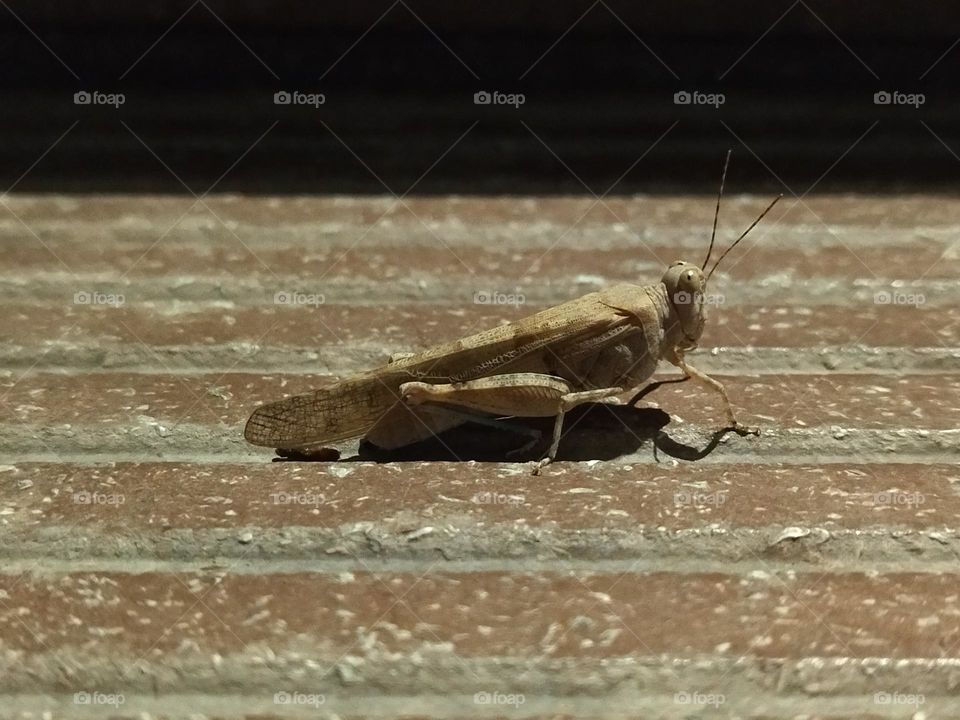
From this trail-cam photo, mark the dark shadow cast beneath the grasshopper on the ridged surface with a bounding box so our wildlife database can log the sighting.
[275,403,732,462]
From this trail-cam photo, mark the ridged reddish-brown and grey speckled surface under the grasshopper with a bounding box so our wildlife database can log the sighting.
[0,194,960,719]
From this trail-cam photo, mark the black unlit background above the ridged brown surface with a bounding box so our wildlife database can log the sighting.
[0,0,960,195]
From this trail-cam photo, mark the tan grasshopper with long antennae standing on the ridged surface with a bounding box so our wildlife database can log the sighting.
[244,152,782,472]
